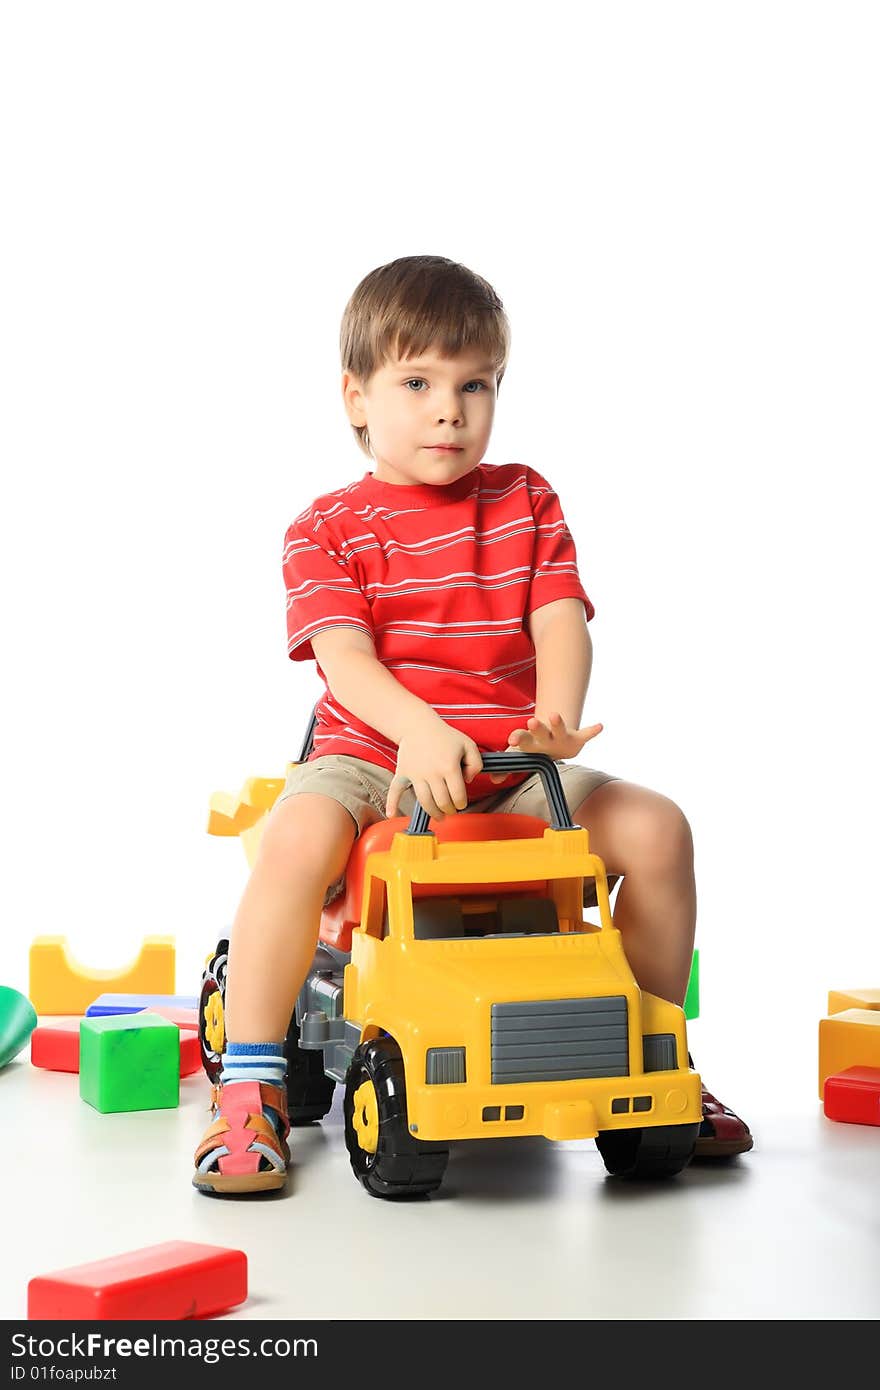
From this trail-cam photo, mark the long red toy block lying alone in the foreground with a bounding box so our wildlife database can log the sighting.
[28,1240,247,1322]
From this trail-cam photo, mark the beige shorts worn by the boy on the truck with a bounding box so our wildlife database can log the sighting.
[275,753,619,906]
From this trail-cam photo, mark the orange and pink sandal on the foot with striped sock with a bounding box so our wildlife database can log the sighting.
[192,1081,291,1193]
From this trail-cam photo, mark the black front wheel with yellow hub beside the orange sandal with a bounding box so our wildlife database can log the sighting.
[343,1037,449,1198]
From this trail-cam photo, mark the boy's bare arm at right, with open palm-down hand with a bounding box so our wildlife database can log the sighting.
[494,598,602,759]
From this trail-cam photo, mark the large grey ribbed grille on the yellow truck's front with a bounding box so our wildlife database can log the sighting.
[492,994,630,1086]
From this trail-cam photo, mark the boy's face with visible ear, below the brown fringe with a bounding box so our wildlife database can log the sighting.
[342,352,496,487]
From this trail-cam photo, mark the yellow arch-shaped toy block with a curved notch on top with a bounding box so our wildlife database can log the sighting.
[28,937,175,1013]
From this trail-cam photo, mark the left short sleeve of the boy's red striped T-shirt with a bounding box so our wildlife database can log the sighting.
[282,513,374,662]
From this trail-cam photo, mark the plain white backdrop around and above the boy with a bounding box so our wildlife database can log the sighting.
[0,0,880,1106]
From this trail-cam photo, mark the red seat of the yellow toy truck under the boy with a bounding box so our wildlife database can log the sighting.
[315,812,548,952]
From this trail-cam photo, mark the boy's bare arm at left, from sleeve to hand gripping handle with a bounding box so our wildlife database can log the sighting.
[311,627,482,817]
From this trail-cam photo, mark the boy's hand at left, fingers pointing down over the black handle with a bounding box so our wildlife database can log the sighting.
[385,712,482,820]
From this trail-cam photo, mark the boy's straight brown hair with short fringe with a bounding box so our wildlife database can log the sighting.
[339,256,510,459]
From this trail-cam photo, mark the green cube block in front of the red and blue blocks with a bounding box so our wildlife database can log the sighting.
[79,1013,181,1115]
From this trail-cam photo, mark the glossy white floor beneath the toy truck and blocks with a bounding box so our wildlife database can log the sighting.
[0,1024,880,1321]
